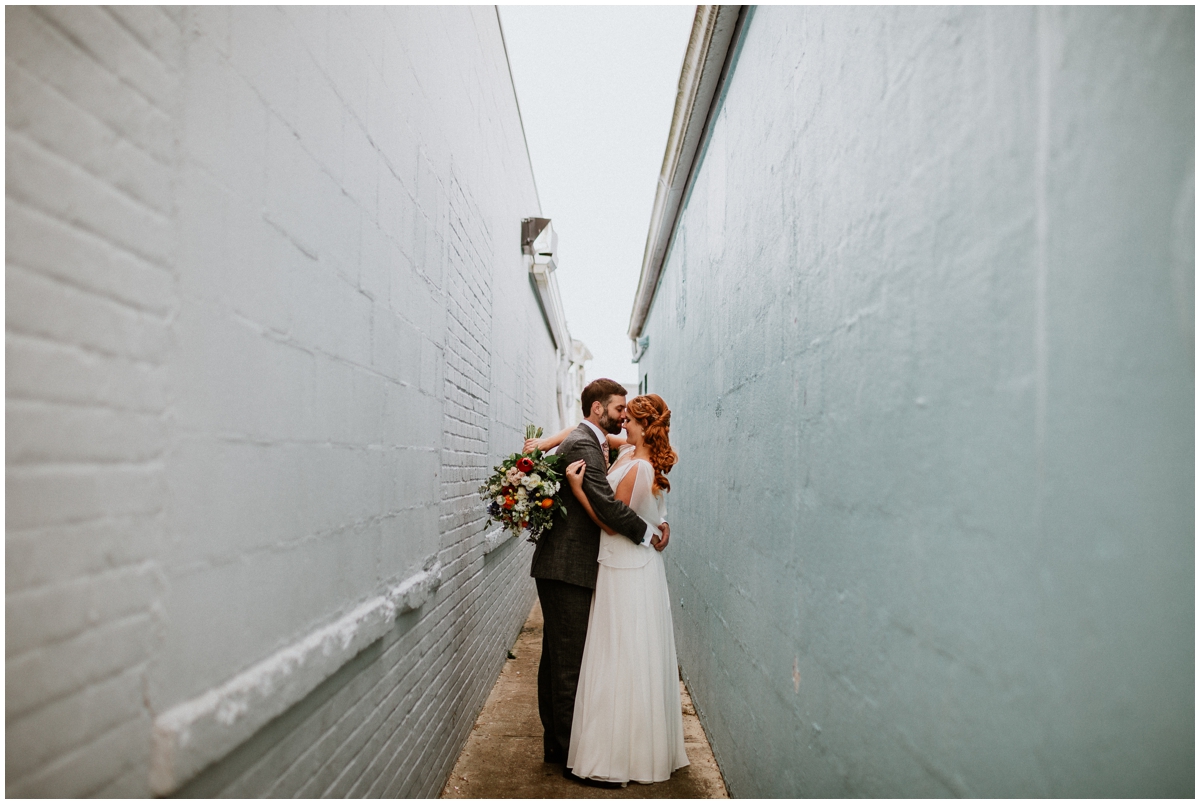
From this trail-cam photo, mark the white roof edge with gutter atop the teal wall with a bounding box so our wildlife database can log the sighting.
[629,6,744,341]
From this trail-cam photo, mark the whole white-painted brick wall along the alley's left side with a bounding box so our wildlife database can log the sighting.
[6,7,558,796]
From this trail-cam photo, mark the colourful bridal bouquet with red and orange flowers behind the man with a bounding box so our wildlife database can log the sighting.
[479,425,566,541]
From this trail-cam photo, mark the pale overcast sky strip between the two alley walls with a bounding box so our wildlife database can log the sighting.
[500,6,696,391]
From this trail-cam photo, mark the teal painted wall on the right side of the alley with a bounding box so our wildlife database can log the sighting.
[640,6,1195,797]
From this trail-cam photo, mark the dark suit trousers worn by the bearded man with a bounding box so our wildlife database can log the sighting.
[536,578,592,762]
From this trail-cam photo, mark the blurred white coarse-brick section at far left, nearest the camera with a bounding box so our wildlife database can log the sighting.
[5,7,179,796]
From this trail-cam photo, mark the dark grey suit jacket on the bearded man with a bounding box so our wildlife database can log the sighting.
[529,422,649,589]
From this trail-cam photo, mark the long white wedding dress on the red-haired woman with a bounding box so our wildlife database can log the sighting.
[566,446,688,782]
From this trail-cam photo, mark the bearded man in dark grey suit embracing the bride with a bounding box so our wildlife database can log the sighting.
[530,379,671,775]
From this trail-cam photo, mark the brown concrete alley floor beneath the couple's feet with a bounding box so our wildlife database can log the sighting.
[442,602,730,798]
